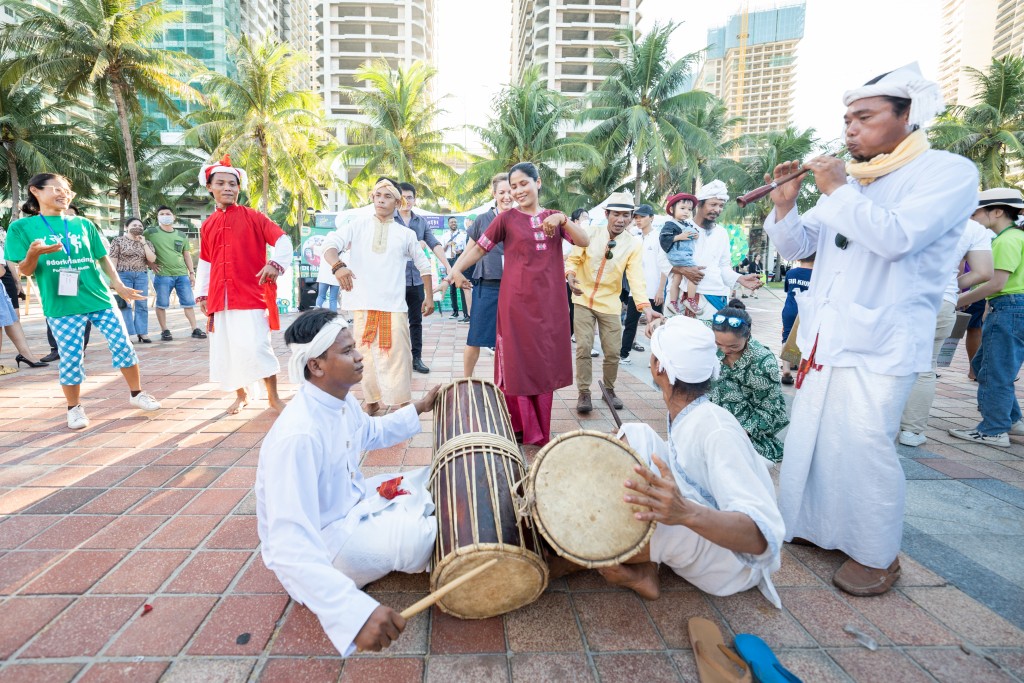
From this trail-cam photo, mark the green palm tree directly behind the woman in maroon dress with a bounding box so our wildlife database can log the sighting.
[458,67,604,211]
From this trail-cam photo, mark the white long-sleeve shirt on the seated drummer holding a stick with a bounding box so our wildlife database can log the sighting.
[256,385,421,656]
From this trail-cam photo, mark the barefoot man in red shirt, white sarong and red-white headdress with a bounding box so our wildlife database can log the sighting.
[196,155,292,415]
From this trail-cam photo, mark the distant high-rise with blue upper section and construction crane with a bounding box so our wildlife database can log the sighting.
[694,3,805,149]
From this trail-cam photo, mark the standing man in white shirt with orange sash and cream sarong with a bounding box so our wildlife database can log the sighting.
[324,178,434,415]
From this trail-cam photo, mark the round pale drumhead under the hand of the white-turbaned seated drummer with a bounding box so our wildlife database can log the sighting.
[527,430,655,567]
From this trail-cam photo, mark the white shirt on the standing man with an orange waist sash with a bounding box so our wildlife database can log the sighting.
[324,215,432,313]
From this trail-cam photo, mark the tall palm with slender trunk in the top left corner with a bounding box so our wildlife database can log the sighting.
[3,0,200,215]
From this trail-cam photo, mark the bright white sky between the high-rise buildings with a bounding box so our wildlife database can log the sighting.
[435,0,941,148]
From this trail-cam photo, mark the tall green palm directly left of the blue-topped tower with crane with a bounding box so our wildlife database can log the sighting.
[581,23,711,202]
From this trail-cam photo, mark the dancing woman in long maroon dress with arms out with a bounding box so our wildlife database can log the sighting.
[446,162,590,445]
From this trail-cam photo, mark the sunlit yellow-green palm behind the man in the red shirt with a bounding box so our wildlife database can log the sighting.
[184,34,328,213]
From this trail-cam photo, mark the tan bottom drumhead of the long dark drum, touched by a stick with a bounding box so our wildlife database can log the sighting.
[430,544,548,618]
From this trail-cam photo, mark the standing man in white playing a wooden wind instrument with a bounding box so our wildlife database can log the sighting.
[765,65,978,595]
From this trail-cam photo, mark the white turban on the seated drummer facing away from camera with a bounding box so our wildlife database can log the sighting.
[650,315,722,384]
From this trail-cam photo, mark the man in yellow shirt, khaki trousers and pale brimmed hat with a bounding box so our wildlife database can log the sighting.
[565,193,662,413]
